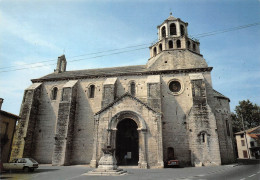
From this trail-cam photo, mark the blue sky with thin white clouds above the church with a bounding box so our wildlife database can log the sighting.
[0,0,260,114]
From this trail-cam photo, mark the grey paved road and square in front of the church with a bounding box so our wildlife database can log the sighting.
[0,165,260,180]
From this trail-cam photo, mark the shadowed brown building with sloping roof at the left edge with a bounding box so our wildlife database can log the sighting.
[0,98,20,163]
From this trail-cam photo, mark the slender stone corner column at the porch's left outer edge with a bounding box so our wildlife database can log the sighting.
[90,116,99,168]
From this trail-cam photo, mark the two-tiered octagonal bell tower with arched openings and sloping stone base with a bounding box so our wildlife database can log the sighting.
[147,13,207,70]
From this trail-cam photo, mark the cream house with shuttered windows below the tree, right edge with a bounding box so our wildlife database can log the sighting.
[235,126,260,159]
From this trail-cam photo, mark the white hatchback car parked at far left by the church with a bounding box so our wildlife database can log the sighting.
[3,158,39,172]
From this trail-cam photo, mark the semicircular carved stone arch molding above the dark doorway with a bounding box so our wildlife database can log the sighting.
[107,111,147,131]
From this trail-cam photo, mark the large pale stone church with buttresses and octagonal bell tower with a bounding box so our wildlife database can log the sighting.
[11,15,234,168]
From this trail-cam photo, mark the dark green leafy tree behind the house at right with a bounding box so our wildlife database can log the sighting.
[231,100,260,132]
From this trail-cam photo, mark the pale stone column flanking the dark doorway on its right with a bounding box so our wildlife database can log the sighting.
[137,129,147,169]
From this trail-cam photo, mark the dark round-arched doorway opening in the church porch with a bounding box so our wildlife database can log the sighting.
[116,118,139,165]
